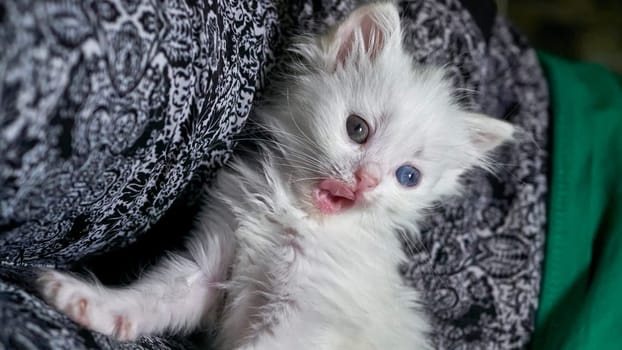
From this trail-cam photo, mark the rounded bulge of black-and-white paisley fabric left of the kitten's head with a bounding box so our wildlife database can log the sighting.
[0,0,276,264]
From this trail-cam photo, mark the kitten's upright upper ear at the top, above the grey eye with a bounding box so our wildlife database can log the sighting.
[329,2,402,67]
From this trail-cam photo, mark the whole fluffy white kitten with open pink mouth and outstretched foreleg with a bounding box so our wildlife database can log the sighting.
[39,4,513,350]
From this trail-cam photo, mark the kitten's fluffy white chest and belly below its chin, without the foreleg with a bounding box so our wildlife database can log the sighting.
[212,157,432,349]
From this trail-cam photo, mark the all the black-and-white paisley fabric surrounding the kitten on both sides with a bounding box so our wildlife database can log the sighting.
[0,0,548,349]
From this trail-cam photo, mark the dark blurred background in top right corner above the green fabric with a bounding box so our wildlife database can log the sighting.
[497,0,622,73]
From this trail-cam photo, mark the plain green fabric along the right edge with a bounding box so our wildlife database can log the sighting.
[532,53,622,350]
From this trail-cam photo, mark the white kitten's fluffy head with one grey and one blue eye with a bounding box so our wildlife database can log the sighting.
[264,4,514,227]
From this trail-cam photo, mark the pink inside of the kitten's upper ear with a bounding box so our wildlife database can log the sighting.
[337,14,384,65]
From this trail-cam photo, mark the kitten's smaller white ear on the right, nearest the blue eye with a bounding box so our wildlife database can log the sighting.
[465,113,516,155]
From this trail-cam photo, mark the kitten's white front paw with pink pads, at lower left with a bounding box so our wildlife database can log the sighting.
[37,271,138,340]
